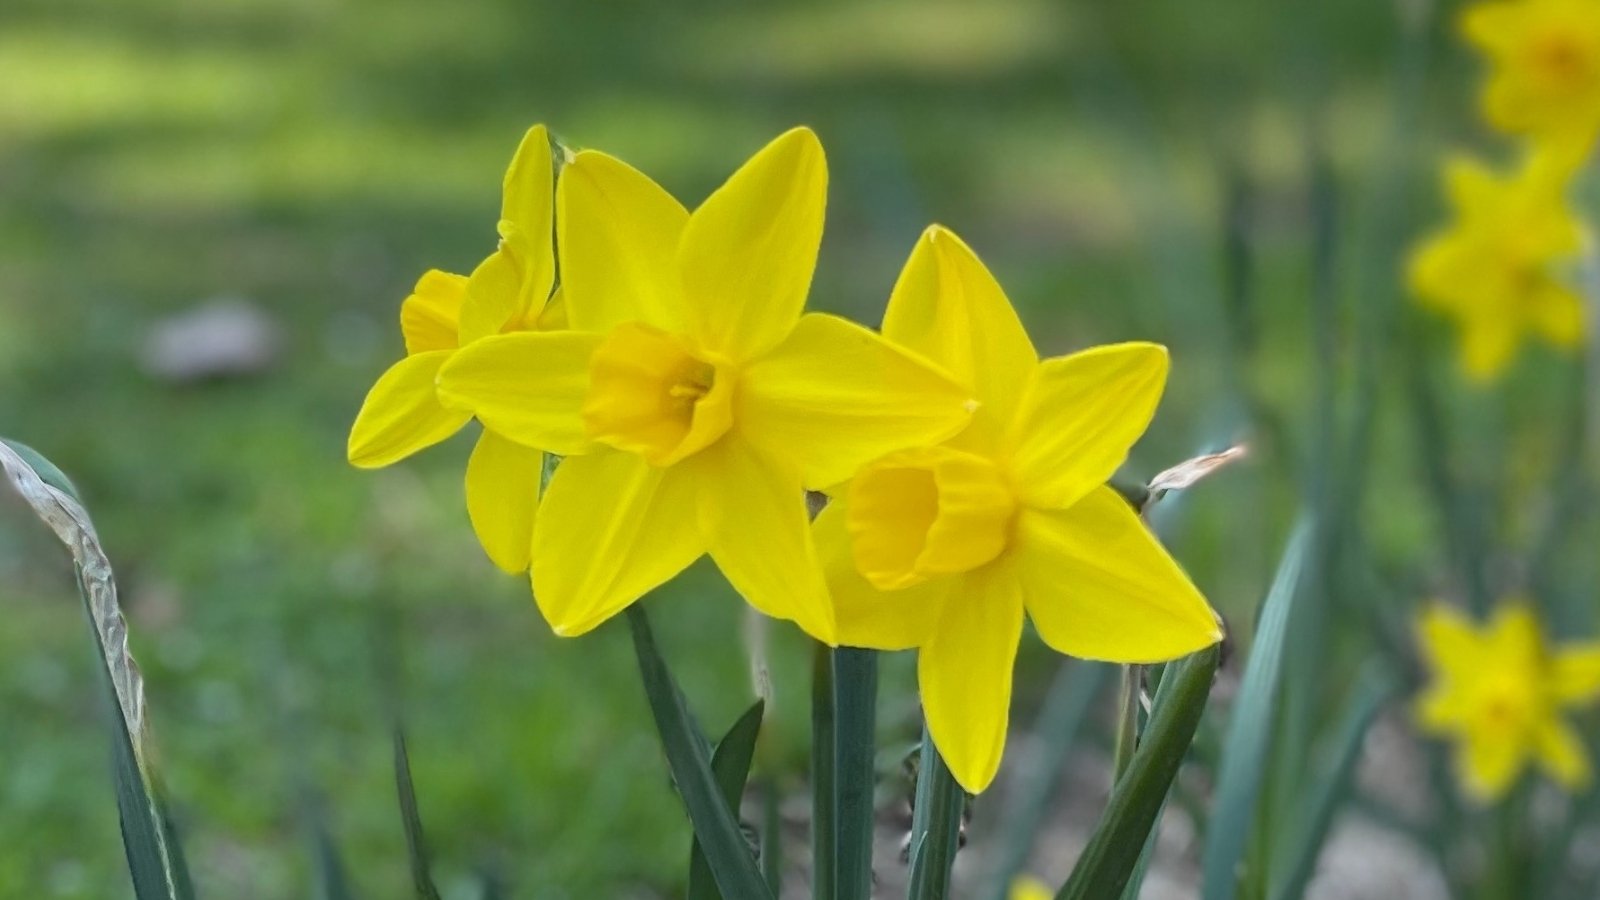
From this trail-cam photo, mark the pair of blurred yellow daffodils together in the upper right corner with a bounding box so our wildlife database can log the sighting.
[1410,0,1600,381]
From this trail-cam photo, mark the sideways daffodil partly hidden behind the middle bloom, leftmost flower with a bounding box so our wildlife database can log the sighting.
[349,125,562,573]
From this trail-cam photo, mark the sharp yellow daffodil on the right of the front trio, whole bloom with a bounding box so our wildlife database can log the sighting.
[814,227,1222,793]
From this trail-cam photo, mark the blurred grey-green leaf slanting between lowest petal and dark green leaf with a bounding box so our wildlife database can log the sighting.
[987,661,1114,900]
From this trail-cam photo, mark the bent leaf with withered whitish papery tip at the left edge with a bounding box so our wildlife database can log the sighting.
[0,440,194,900]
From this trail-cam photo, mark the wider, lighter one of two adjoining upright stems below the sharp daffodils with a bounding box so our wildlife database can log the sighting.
[832,647,878,900]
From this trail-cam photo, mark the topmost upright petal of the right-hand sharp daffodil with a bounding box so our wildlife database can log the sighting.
[883,226,1038,424]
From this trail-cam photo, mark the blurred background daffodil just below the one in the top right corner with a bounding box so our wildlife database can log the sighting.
[1408,154,1584,381]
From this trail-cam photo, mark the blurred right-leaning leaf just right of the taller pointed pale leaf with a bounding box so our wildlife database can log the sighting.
[1270,666,1397,900]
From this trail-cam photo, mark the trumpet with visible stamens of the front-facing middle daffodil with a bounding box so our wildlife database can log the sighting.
[584,323,733,466]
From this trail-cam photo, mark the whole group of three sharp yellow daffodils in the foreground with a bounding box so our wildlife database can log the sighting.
[349,128,1221,791]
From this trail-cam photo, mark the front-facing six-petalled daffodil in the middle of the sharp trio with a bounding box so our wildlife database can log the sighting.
[440,128,971,642]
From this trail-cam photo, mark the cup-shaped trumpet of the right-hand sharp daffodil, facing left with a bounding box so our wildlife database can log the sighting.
[845,447,1016,591]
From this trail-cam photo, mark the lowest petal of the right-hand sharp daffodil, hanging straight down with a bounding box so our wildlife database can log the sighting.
[917,565,1022,794]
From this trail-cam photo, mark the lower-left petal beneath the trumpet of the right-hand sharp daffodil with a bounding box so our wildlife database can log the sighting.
[811,500,940,650]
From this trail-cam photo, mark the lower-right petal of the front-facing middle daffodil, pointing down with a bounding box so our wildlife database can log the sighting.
[680,437,837,644]
